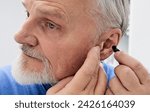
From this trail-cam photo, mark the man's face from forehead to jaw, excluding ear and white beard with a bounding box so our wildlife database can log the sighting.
[12,0,98,84]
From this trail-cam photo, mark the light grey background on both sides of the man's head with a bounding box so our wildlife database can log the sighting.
[0,0,150,69]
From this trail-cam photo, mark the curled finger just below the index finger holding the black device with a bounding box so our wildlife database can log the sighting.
[115,65,141,91]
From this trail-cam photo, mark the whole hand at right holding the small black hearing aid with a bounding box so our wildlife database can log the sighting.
[106,51,150,95]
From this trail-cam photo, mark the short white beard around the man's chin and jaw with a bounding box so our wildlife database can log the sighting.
[12,44,57,85]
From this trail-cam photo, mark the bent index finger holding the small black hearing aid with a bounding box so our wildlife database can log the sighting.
[114,51,148,83]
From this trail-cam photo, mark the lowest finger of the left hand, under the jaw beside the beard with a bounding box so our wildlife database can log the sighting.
[46,77,73,95]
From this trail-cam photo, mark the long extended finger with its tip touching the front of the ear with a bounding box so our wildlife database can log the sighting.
[67,47,100,91]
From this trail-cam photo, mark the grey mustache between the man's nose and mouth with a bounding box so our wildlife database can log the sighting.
[21,44,46,61]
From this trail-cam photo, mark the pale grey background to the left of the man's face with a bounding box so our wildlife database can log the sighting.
[0,0,26,66]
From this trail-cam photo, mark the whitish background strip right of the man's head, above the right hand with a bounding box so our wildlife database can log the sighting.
[129,0,150,70]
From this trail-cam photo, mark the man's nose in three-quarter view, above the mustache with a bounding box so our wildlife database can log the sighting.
[15,21,38,46]
